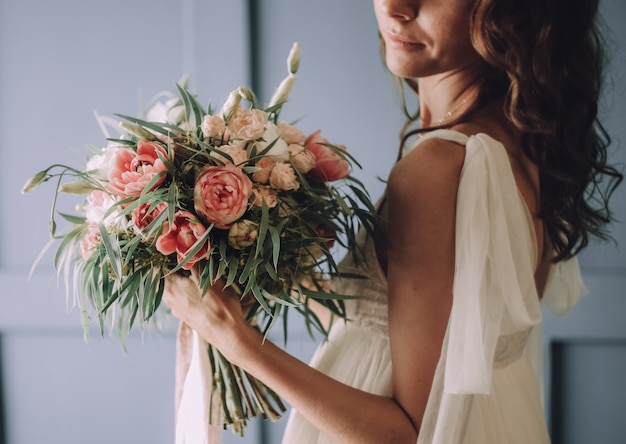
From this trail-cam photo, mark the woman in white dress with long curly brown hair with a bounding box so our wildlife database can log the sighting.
[164,0,621,444]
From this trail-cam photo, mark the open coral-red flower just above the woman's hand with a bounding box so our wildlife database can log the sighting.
[156,211,211,270]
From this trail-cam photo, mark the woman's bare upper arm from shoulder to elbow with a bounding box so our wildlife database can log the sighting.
[387,139,465,430]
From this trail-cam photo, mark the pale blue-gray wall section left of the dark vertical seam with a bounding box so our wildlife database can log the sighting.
[0,0,249,444]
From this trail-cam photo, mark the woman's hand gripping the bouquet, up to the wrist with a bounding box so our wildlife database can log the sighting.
[163,269,247,353]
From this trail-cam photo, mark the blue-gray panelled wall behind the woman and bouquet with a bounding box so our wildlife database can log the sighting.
[0,0,626,444]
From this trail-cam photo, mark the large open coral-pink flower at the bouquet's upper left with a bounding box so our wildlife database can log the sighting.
[107,140,167,198]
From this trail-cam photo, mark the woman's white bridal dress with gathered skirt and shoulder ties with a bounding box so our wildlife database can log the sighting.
[283,130,583,444]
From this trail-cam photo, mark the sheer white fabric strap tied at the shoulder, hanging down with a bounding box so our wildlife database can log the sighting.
[445,133,541,393]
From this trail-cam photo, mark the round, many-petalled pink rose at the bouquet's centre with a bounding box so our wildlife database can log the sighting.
[193,163,252,229]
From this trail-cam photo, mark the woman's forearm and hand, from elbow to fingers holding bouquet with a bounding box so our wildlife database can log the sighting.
[164,276,417,444]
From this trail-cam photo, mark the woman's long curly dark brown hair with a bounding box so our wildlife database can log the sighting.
[394,0,623,261]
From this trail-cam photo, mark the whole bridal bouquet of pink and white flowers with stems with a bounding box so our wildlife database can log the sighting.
[23,44,376,434]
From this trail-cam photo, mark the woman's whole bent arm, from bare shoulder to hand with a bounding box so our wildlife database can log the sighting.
[164,141,463,444]
